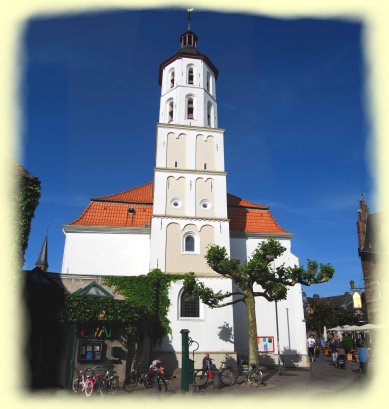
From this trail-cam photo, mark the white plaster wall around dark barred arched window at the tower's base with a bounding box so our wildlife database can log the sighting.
[159,278,234,352]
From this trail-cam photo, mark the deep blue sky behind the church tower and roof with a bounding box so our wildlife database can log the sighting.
[20,9,377,296]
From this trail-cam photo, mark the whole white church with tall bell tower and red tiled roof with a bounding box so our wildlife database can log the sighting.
[61,16,308,367]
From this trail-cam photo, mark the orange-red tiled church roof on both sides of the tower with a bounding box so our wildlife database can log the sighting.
[70,183,288,234]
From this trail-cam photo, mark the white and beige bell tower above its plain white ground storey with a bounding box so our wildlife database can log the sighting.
[150,13,230,276]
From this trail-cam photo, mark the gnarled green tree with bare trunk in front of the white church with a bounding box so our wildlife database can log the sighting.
[184,239,335,364]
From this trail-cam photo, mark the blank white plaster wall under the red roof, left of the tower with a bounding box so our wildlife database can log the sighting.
[62,232,150,276]
